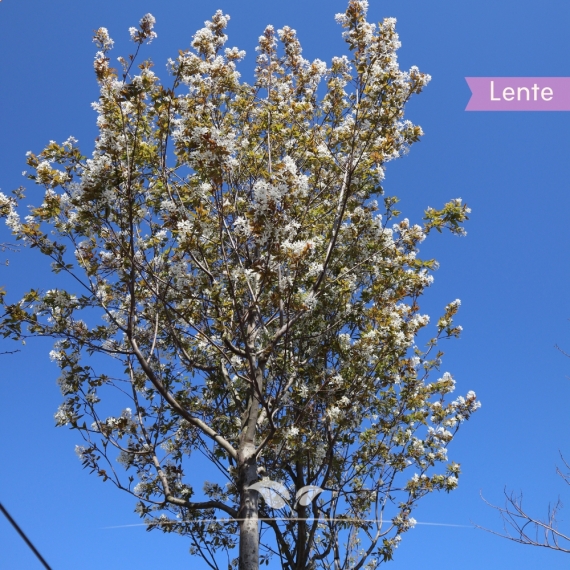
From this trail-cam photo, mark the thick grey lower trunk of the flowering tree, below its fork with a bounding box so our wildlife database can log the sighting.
[238,444,259,570]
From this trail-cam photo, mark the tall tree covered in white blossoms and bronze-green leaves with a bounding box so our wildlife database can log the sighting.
[0,0,479,570]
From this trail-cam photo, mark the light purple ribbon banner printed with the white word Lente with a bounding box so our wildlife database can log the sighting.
[465,77,570,111]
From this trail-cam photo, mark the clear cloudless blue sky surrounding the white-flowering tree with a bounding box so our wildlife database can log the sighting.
[0,0,570,570]
